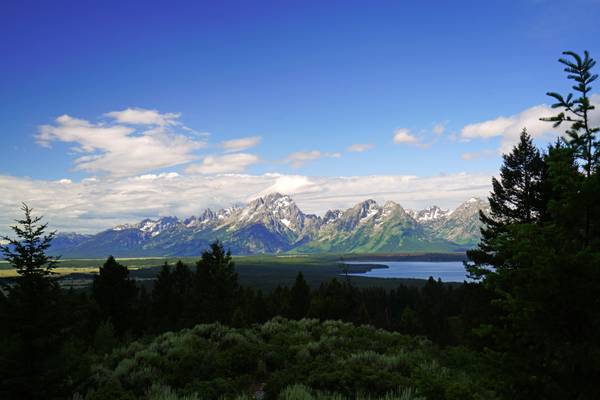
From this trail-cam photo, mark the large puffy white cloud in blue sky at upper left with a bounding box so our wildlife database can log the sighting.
[36,109,205,176]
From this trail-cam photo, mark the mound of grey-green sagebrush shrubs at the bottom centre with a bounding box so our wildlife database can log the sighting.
[88,318,495,400]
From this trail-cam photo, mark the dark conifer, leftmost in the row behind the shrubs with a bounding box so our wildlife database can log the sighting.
[92,256,138,335]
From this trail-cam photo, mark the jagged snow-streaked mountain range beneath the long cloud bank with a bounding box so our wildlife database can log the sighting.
[50,193,487,258]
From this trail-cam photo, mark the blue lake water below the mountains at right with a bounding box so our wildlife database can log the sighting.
[346,261,468,282]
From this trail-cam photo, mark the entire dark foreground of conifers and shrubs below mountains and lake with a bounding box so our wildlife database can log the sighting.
[0,52,600,400]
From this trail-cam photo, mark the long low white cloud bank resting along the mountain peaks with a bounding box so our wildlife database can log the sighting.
[0,172,491,234]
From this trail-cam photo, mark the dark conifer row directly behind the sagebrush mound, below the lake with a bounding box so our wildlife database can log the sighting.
[88,242,490,344]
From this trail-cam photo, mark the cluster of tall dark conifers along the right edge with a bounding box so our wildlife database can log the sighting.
[467,53,600,399]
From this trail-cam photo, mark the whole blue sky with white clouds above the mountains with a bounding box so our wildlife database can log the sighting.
[0,0,600,233]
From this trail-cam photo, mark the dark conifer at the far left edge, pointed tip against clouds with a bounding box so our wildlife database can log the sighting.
[0,204,63,399]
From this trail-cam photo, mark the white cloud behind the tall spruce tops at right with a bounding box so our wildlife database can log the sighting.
[460,94,600,153]
